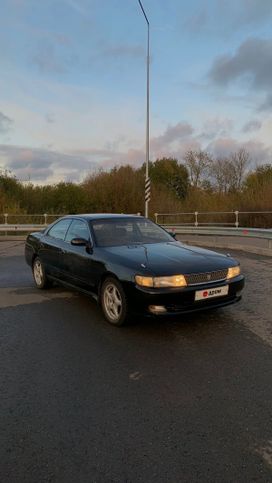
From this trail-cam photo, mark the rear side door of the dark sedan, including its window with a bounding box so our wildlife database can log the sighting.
[39,218,72,278]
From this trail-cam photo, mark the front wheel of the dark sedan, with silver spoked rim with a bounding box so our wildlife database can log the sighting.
[100,277,128,327]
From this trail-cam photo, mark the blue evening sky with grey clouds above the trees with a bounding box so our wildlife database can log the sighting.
[0,0,272,184]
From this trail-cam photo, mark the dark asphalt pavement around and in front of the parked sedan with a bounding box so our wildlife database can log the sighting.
[0,241,272,483]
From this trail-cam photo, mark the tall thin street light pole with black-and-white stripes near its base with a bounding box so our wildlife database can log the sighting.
[138,0,150,218]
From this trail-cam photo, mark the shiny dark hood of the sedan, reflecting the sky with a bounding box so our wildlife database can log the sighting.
[104,242,237,276]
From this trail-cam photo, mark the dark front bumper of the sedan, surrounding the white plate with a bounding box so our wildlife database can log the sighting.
[123,275,244,315]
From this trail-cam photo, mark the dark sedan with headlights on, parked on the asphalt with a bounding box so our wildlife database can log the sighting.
[25,214,244,326]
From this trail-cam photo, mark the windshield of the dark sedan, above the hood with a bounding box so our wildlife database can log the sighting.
[91,218,174,247]
